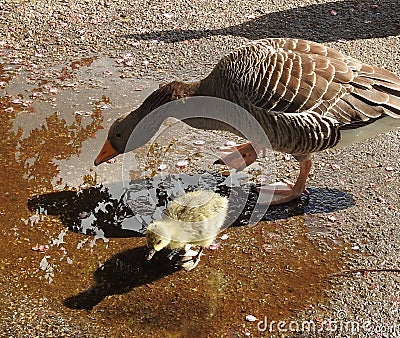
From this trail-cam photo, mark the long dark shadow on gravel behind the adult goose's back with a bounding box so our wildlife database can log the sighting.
[124,0,400,42]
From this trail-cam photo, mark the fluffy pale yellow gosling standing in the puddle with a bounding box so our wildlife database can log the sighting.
[146,190,228,268]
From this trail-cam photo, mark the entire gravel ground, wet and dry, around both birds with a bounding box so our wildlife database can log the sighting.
[0,0,400,338]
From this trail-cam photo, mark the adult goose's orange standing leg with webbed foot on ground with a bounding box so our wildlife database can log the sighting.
[257,159,312,205]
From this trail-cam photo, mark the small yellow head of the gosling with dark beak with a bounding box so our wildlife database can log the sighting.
[146,221,171,260]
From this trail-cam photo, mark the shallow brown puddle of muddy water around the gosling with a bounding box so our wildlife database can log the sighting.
[0,51,353,337]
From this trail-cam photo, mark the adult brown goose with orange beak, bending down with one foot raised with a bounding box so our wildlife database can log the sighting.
[94,38,400,204]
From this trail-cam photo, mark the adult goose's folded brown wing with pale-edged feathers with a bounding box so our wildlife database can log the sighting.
[220,39,400,128]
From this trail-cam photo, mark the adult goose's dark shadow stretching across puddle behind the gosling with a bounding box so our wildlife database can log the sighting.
[28,171,354,237]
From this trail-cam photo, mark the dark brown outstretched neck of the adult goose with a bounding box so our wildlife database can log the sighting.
[135,80,282,148]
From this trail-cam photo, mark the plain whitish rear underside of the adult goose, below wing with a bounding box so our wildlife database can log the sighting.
[333,116,400,149]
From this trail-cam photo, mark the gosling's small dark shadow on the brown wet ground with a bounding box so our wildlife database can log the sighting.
[64,247,178,310]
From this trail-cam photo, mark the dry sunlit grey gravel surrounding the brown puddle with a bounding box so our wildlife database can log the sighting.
[0,0,400,337]
